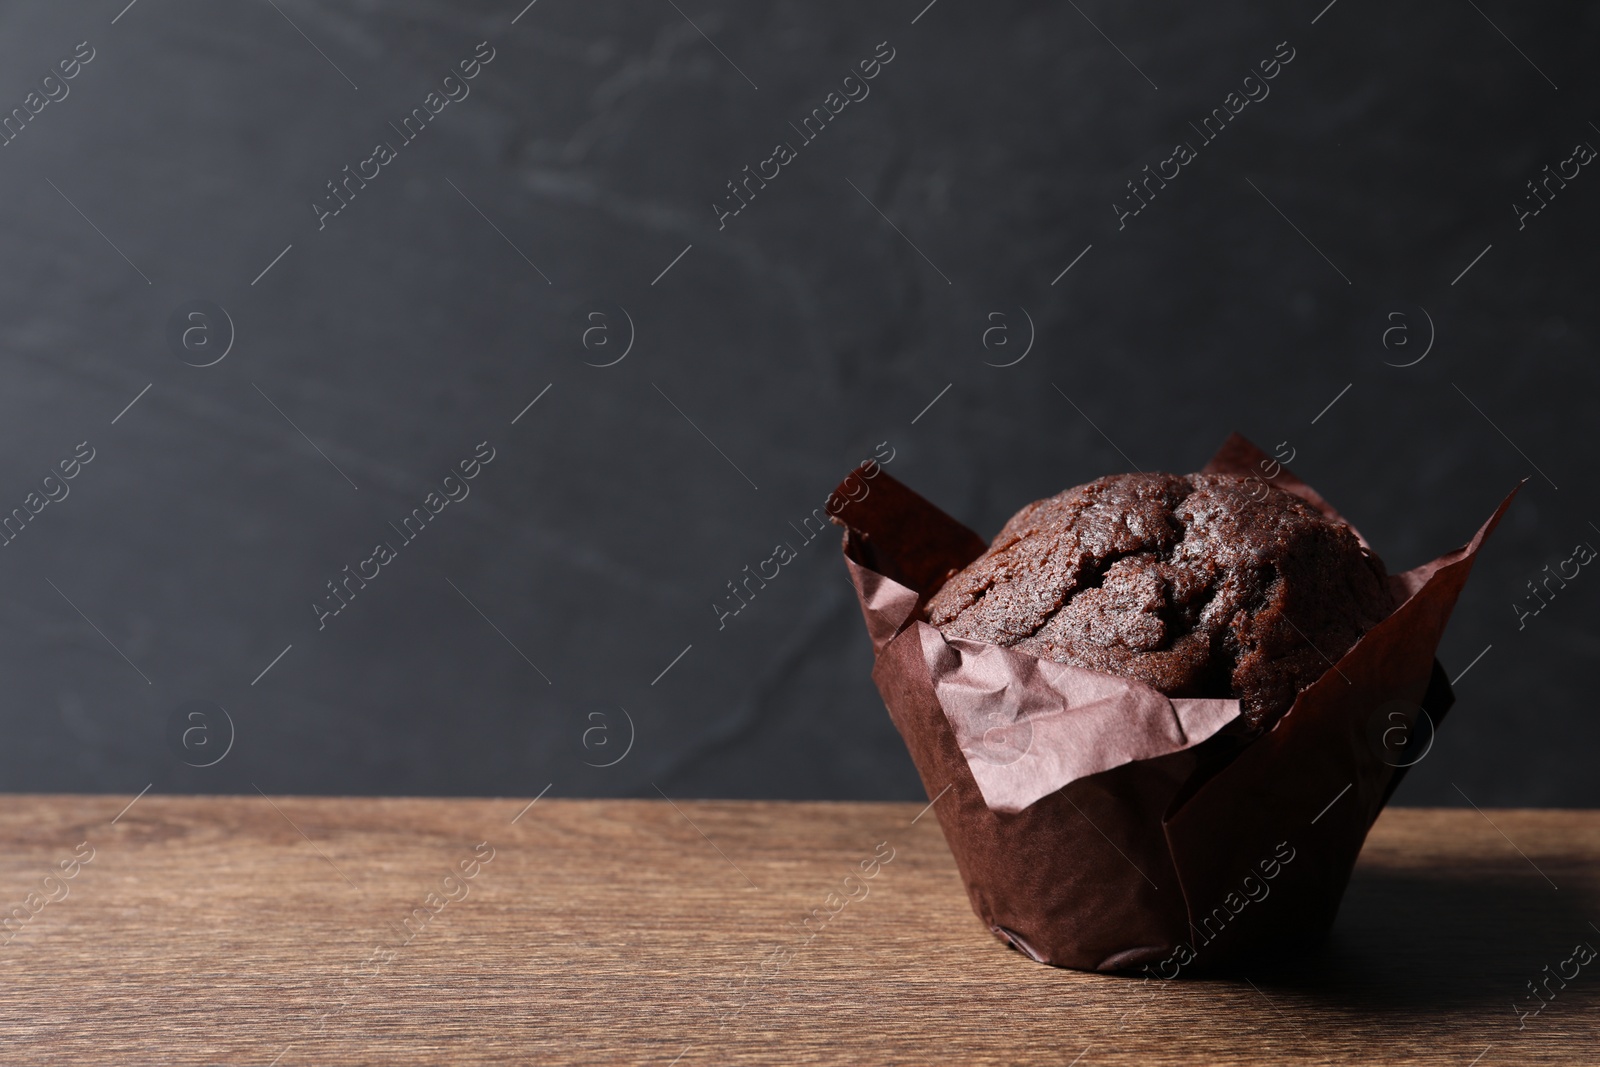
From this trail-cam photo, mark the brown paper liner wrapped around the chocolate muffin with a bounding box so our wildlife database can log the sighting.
[829,434,1515,977]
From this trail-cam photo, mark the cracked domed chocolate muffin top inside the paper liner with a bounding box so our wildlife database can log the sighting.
[925,474,1395,729]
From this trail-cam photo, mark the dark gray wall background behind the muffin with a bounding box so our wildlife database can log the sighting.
[0,0,1600,805]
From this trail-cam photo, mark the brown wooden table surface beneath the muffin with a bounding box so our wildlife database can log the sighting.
[0,795,1600,1067]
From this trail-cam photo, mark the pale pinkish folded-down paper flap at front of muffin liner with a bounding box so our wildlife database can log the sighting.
[917,622,1240,811]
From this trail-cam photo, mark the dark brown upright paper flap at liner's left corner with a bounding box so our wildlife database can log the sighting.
[827,461,989,598]
